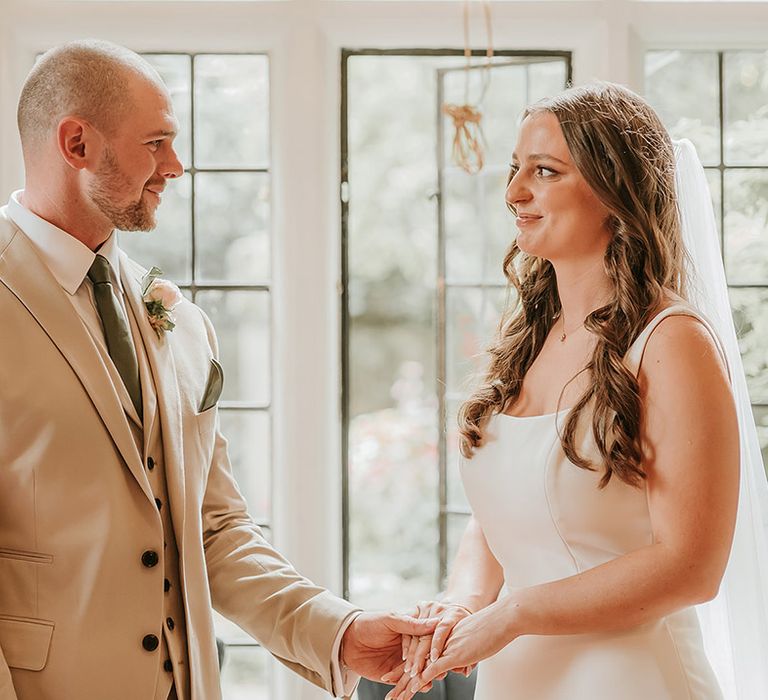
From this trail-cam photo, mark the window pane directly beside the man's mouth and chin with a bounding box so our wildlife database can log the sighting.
[120,174,192,282]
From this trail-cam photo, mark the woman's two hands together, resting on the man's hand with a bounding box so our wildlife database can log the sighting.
[382,603,516,700]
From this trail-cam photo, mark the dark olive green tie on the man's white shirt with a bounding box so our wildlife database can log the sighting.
[88,255,141,419]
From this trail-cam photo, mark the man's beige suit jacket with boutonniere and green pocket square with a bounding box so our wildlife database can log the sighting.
[0,208,355,700]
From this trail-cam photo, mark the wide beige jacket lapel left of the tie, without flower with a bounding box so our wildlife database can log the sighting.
[0,225,152,500]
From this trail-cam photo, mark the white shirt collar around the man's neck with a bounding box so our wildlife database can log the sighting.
[8,190,122,295]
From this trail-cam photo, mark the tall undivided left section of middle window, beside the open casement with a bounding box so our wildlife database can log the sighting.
[347,56,441,607]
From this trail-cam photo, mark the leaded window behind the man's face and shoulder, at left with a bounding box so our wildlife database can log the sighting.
[120,54,272,700]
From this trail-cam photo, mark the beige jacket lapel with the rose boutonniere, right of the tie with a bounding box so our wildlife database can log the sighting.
[120,251,185,548]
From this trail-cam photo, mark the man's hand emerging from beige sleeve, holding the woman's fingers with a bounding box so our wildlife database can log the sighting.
[341,613,440,681]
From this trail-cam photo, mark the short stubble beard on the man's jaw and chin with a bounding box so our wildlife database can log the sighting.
[88,147,157,231]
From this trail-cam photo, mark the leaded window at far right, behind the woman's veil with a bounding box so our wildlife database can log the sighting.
[645,50,768,474]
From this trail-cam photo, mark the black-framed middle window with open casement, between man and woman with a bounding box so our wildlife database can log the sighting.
[342,50,570,607]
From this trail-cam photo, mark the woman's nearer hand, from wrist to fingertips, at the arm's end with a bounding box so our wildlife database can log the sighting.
[400,603,517,700]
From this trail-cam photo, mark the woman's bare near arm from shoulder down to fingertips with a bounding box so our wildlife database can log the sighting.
[404,316,739,697]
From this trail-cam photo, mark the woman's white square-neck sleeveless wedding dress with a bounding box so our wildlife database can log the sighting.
[460,304,728,700]
